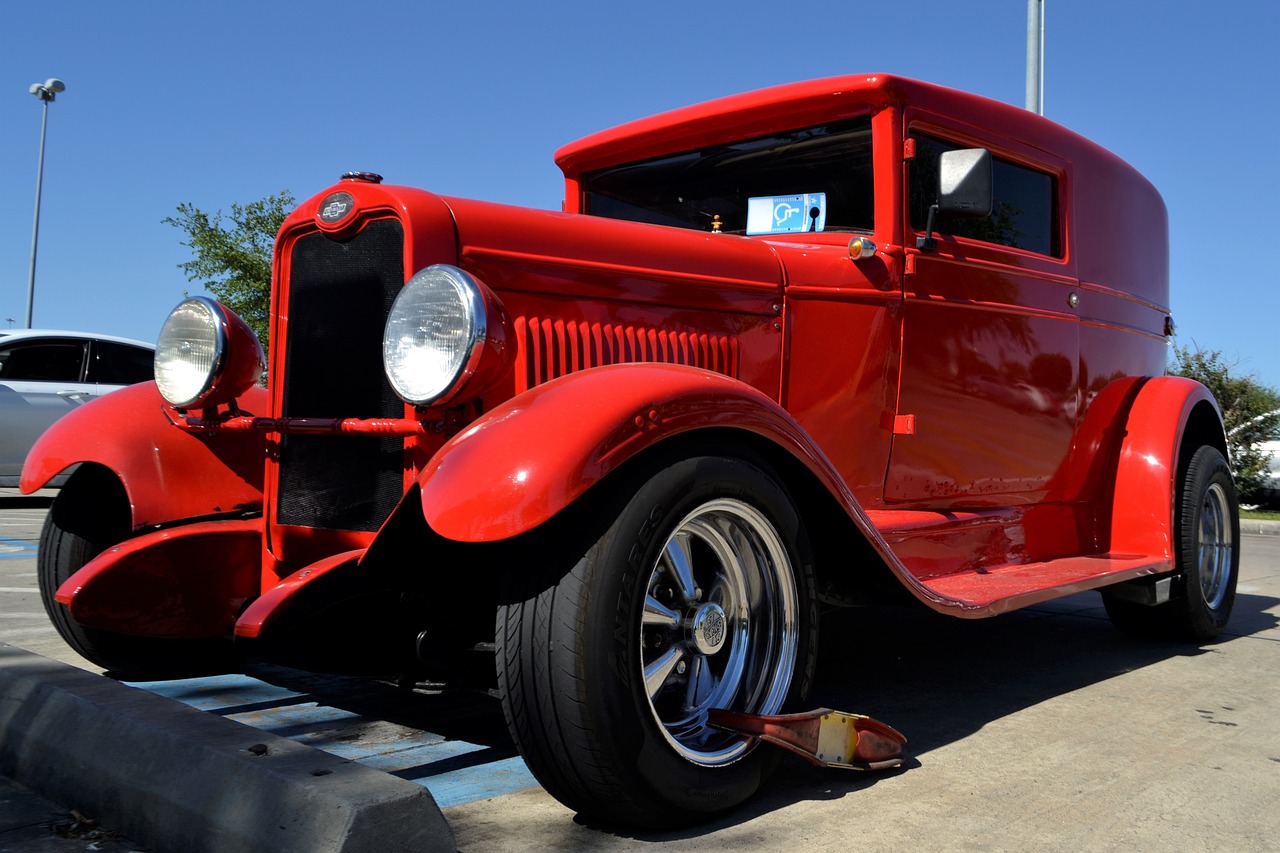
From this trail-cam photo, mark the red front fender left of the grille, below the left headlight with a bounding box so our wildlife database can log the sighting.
[20,382,268,529]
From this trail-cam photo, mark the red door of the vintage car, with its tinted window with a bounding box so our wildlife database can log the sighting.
[884,122,1080,506]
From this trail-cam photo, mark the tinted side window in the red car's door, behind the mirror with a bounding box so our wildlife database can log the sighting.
[909,133,1062,257]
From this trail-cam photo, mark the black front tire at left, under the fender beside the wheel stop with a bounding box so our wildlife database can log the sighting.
[36,465,236,681]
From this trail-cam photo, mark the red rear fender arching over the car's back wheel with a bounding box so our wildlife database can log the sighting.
[1110,377,1225,561]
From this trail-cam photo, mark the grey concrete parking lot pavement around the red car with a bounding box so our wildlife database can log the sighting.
[0,493,1280,853]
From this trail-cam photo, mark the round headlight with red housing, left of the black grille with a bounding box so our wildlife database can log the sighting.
[155,296,265,409]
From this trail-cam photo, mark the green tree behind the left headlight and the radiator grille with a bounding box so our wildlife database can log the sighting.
[163,190,296,348]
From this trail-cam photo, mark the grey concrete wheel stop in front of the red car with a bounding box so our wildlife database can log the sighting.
[0,644,457,853]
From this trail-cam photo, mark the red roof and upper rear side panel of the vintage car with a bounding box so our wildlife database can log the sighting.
[556,74,1169,311]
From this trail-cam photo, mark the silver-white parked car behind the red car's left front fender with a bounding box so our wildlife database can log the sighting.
[0,329,155,487]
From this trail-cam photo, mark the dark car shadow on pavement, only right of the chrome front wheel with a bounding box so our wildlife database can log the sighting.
[627,593,1280,840]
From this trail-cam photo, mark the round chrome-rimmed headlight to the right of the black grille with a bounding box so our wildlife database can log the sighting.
[383,264,489,406]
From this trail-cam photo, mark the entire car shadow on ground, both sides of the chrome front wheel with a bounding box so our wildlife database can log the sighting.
[232,584,1280,841]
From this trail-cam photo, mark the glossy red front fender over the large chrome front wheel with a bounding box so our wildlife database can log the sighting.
[419,364,842,542]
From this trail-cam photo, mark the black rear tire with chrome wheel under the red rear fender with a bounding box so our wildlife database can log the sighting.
[1102,444,1240,643]
